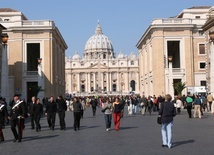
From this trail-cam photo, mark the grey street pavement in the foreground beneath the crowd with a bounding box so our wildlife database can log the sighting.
[0,107,214,155]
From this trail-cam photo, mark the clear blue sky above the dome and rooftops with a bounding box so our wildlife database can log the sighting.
[0,0,214,56]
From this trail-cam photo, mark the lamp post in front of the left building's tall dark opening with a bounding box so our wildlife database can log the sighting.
[37,58,44,99]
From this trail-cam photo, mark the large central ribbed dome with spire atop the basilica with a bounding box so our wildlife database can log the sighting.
[84,23,114,59]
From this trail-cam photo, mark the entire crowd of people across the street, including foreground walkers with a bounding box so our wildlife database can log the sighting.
[0,94,214,148]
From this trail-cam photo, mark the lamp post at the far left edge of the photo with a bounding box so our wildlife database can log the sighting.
[1,33,9,102]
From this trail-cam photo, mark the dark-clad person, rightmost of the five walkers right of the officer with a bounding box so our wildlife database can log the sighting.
[73,96,82,131]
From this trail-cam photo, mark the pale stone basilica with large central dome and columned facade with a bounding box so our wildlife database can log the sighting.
[65,23,139,96]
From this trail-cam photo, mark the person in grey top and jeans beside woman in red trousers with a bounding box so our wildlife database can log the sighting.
[102,98,112,131]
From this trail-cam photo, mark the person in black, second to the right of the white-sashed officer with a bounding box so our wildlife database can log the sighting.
[32,98,43,132]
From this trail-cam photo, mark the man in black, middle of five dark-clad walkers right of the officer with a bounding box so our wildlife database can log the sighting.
[45,96,57,131]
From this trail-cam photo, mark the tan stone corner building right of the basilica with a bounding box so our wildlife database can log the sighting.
[136,6,211,95]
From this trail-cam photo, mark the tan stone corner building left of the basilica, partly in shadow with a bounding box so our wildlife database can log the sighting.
[0,8,67,100]
